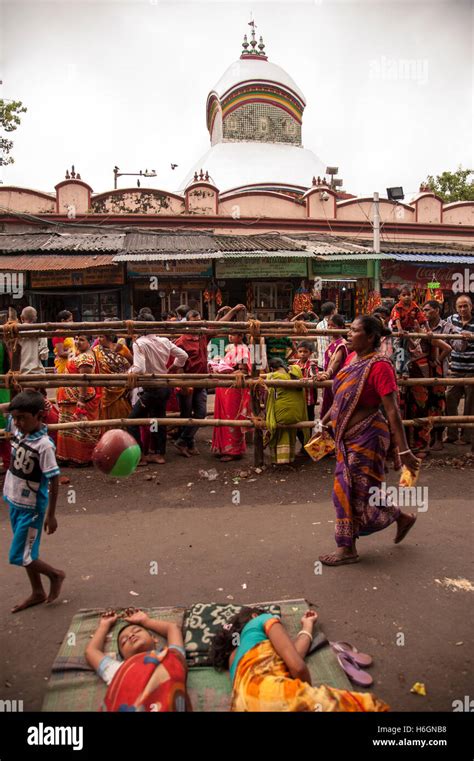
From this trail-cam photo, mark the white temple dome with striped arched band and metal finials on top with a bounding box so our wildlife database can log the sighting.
[180,27,325,194]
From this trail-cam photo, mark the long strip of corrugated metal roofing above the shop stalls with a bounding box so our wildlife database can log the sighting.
[0,229,474,271]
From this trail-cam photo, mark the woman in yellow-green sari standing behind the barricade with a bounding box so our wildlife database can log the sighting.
[266,357,309,465]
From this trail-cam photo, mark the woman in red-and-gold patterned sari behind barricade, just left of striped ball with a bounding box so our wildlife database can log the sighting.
[57,335,100,466]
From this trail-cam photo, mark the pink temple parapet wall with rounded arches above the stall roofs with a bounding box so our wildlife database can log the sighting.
[0,180,474,230]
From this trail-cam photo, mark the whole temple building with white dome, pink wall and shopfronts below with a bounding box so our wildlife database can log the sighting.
[0,27,474,319]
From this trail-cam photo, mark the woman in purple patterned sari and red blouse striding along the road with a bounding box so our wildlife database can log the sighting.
[319,315,419,566]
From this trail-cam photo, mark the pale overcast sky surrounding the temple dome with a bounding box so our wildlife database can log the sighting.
[0,0,474,195]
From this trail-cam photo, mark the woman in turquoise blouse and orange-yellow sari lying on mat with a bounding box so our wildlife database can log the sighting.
[212,608,389,712]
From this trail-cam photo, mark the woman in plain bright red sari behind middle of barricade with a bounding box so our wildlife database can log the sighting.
[211,333,252,462]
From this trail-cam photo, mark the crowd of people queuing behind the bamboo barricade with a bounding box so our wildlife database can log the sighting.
[0,286,474,467]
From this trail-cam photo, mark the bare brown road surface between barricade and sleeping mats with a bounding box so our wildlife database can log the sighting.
[0,430,474,711]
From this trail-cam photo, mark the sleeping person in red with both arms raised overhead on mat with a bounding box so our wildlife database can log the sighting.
[85,611,191,712]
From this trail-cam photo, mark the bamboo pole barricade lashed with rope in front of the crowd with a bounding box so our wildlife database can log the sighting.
[0,320,474,466]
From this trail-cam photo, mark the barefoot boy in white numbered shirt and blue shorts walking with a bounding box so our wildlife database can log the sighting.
[2,391,66,613]
